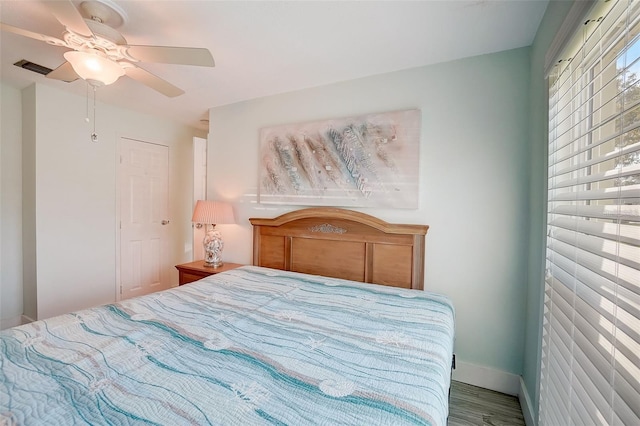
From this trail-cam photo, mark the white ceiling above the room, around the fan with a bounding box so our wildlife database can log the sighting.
[0,0,548,128]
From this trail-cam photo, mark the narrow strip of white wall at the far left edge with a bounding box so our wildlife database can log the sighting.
[0,83,22,329]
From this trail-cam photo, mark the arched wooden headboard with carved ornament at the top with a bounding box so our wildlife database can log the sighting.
[249,207,429,290]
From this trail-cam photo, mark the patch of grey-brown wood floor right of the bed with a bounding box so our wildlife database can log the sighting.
[449,381,525,426]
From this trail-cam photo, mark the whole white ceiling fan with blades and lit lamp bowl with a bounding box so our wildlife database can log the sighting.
[0,0,215,97]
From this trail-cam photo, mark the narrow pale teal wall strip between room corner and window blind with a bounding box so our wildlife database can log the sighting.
[522,1,573,418]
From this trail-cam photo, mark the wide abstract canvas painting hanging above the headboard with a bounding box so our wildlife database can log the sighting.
[258,110,420,209]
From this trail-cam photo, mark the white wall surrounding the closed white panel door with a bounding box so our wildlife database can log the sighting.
[16,85,202,319]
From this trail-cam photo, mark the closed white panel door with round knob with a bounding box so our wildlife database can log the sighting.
[119,138,170,299]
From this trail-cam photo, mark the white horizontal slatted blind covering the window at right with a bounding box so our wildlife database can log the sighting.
[539,0,640,425]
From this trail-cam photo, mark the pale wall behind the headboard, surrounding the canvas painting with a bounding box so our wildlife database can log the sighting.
[208,48,529,377]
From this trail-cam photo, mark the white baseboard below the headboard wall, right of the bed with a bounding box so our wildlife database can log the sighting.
[453,359,520,396]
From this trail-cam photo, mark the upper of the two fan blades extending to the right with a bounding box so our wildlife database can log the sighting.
[127,46,215,67]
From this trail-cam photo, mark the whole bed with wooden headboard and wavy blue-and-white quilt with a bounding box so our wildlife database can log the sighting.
[0,209,454,425]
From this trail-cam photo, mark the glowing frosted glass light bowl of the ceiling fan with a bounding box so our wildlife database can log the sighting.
[64,51,124,86]
